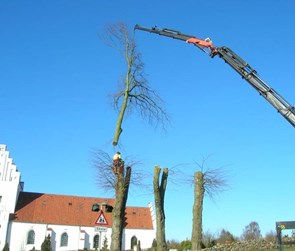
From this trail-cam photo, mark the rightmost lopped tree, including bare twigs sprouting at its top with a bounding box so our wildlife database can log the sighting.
[192,159,228,251]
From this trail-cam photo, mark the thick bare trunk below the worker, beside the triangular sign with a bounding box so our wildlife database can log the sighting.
[110,167,131,251]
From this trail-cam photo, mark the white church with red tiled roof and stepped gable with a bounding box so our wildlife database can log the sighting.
[0,145,155,251]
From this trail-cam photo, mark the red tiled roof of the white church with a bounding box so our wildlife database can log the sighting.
[12,192,153,229]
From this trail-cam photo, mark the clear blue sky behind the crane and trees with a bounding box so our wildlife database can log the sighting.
[0,0,295,241]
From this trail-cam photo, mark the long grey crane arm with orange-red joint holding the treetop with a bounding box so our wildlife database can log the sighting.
[134,25,295,127]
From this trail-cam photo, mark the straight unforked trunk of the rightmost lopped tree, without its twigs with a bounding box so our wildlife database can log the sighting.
[192,172,205,251]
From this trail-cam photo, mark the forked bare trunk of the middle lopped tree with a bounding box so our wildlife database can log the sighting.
[154,166,168,251]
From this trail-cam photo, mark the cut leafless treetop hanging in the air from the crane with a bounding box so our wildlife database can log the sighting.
[104,23,169,146]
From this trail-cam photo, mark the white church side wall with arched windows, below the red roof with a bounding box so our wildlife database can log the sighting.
[8,222,155,251]
